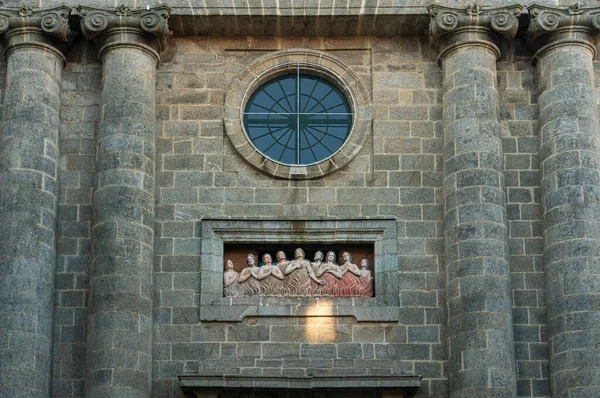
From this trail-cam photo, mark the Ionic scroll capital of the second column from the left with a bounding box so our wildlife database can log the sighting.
[77,5,171,63]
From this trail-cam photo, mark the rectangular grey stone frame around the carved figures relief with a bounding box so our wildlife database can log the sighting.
[200,218,399,322]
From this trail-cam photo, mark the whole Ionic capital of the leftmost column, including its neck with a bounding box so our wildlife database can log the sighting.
[0,6,71,63]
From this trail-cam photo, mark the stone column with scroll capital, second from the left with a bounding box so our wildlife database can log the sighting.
[78,6,169,397]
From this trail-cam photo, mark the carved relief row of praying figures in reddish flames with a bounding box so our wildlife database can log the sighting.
[223,248,373,297]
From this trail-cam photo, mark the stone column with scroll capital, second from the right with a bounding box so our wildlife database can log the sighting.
[429,5,521,398]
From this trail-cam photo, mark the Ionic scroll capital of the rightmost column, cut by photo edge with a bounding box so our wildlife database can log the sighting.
[527,3,600,63]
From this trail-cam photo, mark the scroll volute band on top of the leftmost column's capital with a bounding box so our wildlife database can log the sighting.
[0,6,71,42]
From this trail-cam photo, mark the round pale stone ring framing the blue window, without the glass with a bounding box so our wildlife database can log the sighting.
[223,49,372,179]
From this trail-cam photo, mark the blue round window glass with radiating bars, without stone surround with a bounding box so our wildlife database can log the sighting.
[243,64,353,166]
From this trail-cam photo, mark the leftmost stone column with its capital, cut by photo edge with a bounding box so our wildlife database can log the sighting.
[0,7,69,397]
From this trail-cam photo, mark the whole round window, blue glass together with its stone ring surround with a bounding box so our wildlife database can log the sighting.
[223,49,372,179]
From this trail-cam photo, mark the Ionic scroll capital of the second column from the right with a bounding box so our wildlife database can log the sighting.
[427,3,523,63]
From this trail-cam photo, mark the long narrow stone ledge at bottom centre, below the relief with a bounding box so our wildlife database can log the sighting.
[179,375,422,395]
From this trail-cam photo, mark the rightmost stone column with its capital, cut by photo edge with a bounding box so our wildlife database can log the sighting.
[529,5,600,397]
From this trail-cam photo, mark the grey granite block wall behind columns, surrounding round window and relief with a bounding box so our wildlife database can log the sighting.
[53,37,549,397]
